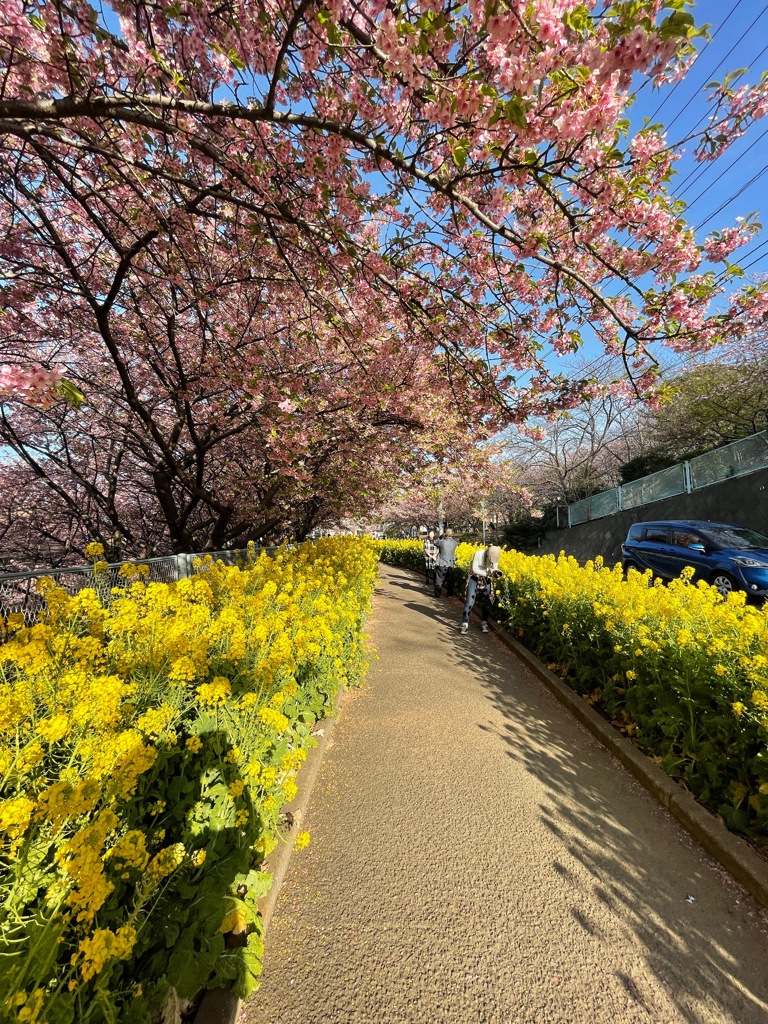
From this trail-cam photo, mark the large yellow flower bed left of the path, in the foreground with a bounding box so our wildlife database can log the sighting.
[0,540,377,1024]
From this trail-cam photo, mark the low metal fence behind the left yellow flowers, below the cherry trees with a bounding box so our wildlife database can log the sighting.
[0,548,274,626]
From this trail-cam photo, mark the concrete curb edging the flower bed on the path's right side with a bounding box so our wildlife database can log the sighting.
[490,621,768,907]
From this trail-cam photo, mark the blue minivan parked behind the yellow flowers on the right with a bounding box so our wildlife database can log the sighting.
[622,519,768,599]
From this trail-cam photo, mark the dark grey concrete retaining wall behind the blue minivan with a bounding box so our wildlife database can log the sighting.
[532,469,768,565]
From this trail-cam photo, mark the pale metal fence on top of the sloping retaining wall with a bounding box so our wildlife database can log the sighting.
[568,430,768,526]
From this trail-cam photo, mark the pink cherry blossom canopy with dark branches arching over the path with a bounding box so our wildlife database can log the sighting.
[0,0,768,551]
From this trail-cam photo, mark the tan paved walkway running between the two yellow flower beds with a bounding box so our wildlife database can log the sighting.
[245,568,768,1024]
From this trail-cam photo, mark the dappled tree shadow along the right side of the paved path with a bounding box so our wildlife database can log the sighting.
[376,567,768,1024]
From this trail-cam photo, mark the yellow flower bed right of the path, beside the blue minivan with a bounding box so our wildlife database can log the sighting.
[380,541,768,835]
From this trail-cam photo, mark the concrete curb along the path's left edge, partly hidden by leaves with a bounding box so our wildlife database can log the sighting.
[194,690,347,1024]
